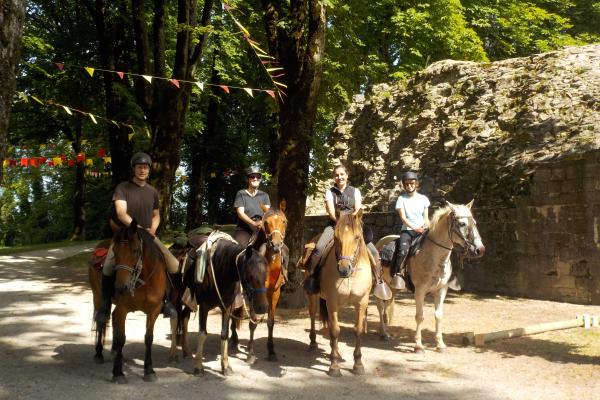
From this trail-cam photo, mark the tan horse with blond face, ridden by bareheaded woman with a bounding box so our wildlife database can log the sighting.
[309,209,372,377]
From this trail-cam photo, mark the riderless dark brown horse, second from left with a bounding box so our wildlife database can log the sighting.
[184,239,267,375]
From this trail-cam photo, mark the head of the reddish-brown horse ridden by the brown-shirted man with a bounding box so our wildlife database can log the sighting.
[113,219,143,294]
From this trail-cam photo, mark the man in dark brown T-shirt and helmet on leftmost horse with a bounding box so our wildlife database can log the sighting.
[96,153,179,323]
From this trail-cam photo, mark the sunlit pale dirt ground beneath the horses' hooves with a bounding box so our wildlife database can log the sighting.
[0,245,600,400]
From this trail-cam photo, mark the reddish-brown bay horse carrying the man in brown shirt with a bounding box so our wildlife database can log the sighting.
[96,219,173,383]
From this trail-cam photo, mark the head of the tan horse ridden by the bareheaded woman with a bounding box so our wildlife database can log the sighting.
[333,209,364,278]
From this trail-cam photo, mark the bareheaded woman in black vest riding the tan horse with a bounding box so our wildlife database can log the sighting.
[304,164,381,295]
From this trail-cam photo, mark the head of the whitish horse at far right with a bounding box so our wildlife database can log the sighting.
[447,200,485,258]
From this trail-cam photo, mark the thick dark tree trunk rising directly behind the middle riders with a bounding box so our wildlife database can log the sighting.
[262,0,326,268]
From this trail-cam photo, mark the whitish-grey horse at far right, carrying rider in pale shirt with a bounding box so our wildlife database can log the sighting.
[376,201,485,352]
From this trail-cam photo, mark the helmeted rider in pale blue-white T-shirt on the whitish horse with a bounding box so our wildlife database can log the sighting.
[391,171,430,289]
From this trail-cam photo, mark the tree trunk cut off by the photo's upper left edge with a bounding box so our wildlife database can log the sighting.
[0,0,27,184]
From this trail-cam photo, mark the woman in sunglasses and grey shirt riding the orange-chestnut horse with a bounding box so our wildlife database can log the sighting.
[233,166,271,246]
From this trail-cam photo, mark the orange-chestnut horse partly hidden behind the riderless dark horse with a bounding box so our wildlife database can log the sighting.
[231,200,289,364]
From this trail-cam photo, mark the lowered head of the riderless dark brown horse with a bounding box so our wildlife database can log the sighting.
[238,246,269,314]
